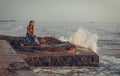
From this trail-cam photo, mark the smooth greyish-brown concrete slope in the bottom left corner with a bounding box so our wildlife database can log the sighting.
[0,40,35,76]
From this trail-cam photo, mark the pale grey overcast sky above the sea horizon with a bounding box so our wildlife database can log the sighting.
[0,0,120,22]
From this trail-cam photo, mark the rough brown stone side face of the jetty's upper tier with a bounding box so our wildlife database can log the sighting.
[19,42,76,53]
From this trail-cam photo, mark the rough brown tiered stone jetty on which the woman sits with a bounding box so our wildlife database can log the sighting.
[0,35,99,67]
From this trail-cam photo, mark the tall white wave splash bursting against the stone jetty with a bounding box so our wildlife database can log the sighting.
[59,28,98,53]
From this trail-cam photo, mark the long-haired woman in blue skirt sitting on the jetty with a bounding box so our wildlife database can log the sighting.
[25,20,40,46]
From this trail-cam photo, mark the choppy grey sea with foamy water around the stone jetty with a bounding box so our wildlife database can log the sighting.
[0,21,120,76]
